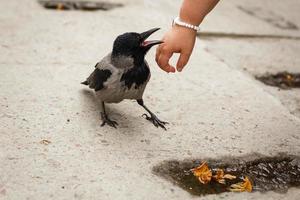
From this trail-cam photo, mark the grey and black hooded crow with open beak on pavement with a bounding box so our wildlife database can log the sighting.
[82,28,167,130]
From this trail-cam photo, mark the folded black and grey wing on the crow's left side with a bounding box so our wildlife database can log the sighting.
[82,54,113,91]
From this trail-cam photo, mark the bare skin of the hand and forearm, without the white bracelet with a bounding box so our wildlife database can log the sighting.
[155,0,219,73]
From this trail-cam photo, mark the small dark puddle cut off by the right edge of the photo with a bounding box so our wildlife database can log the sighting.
[256,72,300,89]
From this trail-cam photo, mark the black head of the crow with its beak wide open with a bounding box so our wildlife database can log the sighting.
[112,28,162,60]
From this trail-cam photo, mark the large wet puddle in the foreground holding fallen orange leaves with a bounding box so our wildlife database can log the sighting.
[153,154,300,196]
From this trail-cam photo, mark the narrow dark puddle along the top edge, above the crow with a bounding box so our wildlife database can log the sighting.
[39,0,123,11]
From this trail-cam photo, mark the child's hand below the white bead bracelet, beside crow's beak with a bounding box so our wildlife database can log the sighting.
[155,25,197,73]
